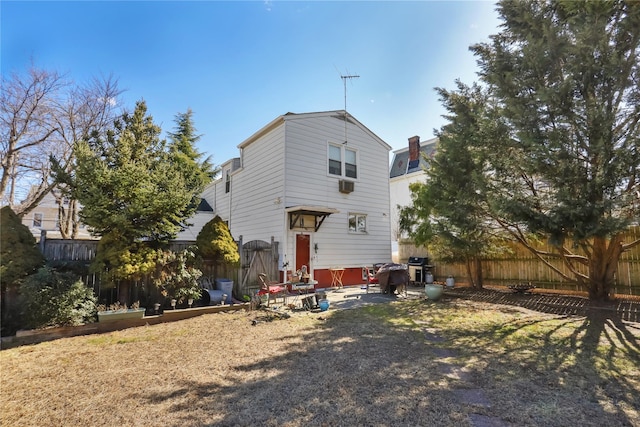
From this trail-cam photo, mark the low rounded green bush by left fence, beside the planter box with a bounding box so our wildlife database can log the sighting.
[20,267,96,329]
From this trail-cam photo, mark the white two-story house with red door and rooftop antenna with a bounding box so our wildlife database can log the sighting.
[193,111,391,287]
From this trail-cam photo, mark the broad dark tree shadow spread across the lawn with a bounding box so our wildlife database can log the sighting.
[132,298,640,426]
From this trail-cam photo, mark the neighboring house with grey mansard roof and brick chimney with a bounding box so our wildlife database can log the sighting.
[389,136,438,263]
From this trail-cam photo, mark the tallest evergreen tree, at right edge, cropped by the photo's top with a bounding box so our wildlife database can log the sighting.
[472,0,640,299]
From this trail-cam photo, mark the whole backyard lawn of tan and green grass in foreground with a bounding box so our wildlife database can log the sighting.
[0,297,640,426]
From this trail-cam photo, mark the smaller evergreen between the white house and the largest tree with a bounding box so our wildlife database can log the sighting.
[400,81,510,288]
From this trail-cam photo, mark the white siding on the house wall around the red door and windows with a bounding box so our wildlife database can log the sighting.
[285,116,391,269]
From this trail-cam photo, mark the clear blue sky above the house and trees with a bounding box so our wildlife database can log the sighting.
[0,0,499,164]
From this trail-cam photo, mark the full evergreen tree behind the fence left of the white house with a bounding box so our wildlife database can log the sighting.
[72,101,198,288]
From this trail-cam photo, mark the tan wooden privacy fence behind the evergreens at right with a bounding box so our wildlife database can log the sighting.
[433,227,640,295]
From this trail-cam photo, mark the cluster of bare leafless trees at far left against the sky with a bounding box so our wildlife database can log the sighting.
[0,66,121,238]
